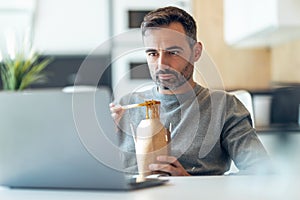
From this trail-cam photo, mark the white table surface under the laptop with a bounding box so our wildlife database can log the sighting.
[0,175,300,200]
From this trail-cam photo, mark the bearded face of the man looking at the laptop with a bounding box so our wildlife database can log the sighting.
[144,23,194,91]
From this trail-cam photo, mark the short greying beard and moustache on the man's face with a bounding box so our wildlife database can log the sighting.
[152,64,193,91]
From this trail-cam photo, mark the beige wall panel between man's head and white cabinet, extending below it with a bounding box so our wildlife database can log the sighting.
[193,0,274,90]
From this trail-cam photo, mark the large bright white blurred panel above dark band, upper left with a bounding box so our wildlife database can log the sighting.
[33,0,111,55]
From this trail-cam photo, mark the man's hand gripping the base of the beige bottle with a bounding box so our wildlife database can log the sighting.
[149,156,190,176]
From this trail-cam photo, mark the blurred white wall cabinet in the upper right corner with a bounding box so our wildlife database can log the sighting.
[224,0,300,47]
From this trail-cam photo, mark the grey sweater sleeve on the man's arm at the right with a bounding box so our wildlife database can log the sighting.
[221,95,271,174]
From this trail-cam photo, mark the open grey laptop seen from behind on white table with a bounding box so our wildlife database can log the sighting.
[0,88,167,190]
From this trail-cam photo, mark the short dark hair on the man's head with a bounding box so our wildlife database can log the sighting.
[141,6,197,46]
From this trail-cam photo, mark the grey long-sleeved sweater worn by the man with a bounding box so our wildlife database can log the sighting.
[119,85,269,175]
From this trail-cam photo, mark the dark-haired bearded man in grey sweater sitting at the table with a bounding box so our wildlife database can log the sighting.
[110,7,268,176]
